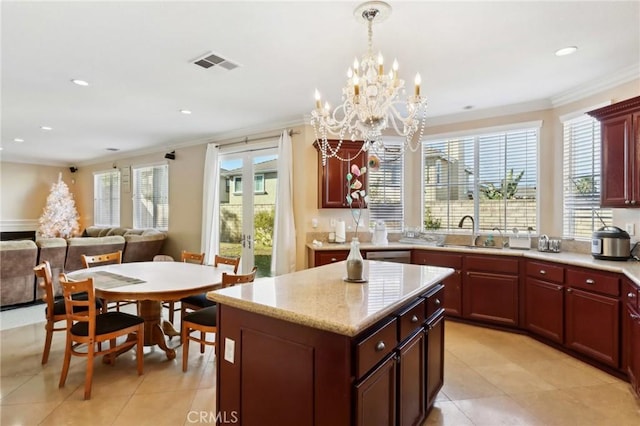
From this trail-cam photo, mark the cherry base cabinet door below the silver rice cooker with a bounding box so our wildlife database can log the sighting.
[565,288,620,368]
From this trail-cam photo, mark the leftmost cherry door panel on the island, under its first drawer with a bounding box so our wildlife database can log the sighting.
[355,355,396,426]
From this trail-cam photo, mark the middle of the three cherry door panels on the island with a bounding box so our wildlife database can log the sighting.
[398,330,426,426]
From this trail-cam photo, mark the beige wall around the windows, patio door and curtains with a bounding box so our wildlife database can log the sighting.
[1,80,640,269]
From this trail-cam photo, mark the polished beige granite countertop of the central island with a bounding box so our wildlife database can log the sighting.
[207,260,454,337]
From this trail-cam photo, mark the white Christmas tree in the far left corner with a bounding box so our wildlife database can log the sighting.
[38,173,79,238]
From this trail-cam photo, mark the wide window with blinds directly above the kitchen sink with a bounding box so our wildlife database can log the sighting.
[422,128,539,232]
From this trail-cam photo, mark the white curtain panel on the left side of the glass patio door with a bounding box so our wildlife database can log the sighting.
[200,144,220,264]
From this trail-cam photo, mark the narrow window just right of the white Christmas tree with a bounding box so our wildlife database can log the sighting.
[93,170,120,227]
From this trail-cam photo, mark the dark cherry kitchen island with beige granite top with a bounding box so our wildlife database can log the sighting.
[208,261,453,426]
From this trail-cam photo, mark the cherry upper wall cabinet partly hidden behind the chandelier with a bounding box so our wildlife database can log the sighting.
[313,140,367,209]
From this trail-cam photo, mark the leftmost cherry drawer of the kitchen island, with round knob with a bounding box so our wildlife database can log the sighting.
[355,317,398,379]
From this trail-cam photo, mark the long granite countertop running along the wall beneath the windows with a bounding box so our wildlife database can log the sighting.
[307,242,640,286]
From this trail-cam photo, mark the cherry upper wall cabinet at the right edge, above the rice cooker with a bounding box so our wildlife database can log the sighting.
[588,96,640,207]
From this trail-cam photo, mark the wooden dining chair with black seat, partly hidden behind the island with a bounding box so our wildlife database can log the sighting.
[181,266,258,371]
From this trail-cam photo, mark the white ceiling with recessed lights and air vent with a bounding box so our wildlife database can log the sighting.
[0,1,640,165]
